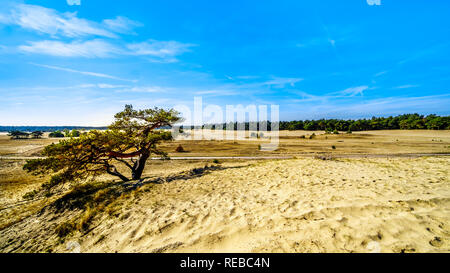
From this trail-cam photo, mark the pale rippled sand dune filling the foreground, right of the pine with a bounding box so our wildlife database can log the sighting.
[0,157,450,252]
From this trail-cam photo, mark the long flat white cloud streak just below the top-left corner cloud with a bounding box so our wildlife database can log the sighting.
[19,40,121,58]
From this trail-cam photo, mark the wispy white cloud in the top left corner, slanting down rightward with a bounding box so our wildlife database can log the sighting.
[6,4,117,38]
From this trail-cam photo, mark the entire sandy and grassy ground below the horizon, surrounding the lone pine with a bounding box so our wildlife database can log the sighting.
[0,130,450,252]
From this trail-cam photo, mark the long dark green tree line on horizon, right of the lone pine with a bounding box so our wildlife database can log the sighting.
[182,114,450,132]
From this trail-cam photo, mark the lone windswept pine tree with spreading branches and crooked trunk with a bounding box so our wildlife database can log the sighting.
[24,105,180,189]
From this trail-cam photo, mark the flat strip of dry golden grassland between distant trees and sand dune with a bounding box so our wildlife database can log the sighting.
[0,130,450,157]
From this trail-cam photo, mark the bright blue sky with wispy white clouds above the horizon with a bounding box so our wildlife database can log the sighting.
[0,0,450,125]
